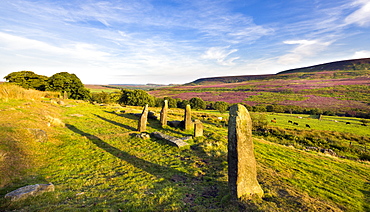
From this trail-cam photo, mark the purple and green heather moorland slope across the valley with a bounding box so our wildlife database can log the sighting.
[149,59,370,118]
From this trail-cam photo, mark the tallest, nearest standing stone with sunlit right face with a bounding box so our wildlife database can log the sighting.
[227,105,263,199]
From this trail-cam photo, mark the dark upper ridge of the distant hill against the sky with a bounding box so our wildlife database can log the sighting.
[188,58,370,84]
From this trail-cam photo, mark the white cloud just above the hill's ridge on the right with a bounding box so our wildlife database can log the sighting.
[278,40,331,65]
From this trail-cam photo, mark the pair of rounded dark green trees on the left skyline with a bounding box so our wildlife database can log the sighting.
[4,71,91,100]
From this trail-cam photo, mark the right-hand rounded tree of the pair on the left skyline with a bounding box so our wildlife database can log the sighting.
[46,72,91,100]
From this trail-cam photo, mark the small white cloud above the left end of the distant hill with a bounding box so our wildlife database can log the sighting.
[201,46,239,66]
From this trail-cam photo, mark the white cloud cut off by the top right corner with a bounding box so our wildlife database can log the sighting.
[344,0,370,26]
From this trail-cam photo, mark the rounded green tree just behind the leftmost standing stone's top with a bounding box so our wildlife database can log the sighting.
[118,89,155,106]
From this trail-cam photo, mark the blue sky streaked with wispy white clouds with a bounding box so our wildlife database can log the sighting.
[0,0,370,84]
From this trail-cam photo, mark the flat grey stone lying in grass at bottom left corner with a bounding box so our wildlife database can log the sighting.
[5,183,54,201]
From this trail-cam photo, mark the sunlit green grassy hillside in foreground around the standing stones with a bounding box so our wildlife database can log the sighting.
[0,85,370,211]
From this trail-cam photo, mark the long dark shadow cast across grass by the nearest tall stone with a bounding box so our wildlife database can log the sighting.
[66,124,228,208]
